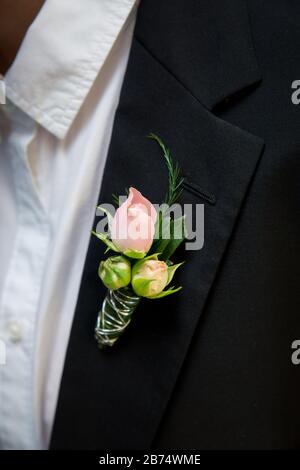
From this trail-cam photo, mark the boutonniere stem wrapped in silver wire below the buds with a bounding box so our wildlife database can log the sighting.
[95,287,141,349]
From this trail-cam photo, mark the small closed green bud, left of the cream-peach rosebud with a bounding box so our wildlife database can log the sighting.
[99,256,131,290]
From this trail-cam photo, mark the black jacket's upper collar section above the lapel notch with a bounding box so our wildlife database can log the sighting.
[135,0,261,109]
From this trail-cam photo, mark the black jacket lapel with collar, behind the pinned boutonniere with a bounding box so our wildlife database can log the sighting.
[51,0,263,449]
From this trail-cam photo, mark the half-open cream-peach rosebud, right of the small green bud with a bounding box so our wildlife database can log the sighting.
[131,259,168,298]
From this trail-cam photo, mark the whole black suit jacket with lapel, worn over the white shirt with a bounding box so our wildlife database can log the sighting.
[51,0,300,449]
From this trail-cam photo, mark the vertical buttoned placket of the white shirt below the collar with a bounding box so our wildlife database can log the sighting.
[0,108,50,449]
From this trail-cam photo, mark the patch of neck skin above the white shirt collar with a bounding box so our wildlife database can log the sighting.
[0,0,45,75]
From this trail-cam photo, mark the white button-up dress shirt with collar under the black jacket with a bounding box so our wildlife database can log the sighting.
[0,0,137,449]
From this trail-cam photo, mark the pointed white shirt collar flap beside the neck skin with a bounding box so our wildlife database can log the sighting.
[5,0,136,139]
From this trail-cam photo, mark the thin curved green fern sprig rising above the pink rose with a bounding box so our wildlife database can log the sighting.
[148,132,184,206]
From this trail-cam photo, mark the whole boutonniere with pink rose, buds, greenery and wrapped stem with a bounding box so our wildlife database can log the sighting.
[92,134,186,349]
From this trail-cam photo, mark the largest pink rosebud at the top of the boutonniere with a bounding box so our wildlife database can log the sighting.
[111,188,157,258]
